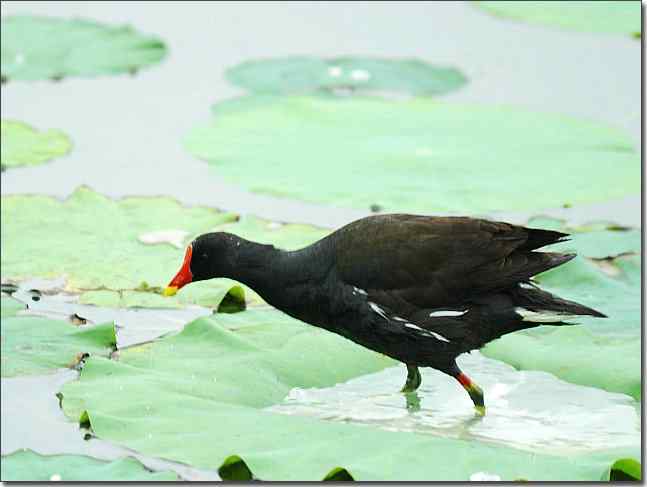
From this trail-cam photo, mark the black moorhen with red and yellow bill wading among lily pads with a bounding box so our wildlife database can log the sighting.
[164,214,605,414]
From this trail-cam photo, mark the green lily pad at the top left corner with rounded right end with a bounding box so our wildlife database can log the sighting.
[2,15,166,80]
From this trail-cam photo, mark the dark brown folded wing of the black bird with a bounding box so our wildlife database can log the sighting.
[332,214,566,313]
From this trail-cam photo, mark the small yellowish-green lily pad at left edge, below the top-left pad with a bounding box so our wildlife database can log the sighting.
[0,120,72,169]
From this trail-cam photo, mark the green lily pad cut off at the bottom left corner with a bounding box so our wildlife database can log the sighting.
[1,450,179,482]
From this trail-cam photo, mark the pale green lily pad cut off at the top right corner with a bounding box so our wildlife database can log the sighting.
[475,1,641,34]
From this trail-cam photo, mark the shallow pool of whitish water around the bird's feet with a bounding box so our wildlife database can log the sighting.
[270,352,640,453]
